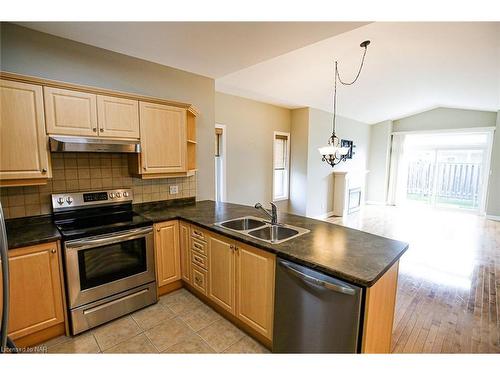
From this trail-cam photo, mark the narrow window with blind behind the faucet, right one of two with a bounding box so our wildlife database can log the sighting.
[273,132,290,201]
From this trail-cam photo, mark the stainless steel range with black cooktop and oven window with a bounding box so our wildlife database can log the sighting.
[52,189,158,334]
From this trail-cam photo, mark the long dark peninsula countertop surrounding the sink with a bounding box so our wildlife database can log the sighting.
[134,201,408,287]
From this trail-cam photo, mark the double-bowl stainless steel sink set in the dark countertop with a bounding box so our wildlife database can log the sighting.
[215,216,309,244]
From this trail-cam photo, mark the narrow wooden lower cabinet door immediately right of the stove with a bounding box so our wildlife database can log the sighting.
[154,220,181,287]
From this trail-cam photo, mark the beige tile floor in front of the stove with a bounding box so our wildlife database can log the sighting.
[42,289,269,353]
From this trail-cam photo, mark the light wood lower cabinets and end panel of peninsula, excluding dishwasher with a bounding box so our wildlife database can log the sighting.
[168,221,399,353]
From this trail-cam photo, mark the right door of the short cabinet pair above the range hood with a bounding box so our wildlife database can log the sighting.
[97,95,139,139]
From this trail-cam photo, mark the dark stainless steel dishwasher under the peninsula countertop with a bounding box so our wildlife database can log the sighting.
[273,258,361,353]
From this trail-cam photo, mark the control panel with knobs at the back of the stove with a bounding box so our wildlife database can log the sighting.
[52,189,133,212]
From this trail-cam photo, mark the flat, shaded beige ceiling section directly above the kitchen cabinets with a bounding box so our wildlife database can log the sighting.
[18,22,367,78]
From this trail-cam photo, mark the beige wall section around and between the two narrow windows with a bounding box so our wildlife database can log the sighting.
[211,92,293,209]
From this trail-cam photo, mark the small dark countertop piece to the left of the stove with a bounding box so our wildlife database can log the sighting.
[5,216,61,250]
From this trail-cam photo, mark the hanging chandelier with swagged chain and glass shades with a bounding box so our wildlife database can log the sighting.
[318,40,370,168]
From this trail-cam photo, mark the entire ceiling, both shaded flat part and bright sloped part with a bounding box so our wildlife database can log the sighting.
[20,22,500,124]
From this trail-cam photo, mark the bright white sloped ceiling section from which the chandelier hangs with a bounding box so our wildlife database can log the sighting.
[216,22,500,124]
